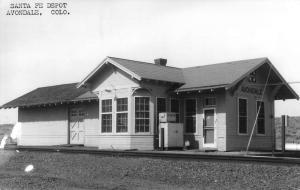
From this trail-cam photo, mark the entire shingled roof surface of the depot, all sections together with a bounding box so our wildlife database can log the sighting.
[0,57,298,108]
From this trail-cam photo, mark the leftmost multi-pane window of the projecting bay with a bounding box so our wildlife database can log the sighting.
[101,100,112,133]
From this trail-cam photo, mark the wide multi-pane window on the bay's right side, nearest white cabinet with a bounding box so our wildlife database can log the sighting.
[135,97,150,133]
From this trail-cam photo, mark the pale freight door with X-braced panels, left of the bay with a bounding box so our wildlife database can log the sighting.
[69,108,85,145]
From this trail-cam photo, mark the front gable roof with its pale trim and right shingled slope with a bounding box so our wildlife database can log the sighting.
[78,57,185,87]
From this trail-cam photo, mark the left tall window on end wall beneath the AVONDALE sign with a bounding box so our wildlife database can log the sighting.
[238,98,248,134]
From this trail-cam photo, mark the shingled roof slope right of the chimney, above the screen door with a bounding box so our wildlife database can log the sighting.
[178,58,267,91]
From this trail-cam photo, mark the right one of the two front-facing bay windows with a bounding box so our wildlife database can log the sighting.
[117,98,128,133]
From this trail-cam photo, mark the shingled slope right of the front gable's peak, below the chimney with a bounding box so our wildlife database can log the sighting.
[108,57,185,84]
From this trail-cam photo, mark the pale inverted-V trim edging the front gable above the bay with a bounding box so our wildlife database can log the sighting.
[77,57,142,88]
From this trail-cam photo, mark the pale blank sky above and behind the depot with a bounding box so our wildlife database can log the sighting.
[0,0,300,123]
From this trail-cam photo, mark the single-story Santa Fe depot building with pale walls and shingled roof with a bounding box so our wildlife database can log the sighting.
[1,57,299,151]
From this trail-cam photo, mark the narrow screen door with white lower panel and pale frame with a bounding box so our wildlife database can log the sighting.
[203,108,216,147]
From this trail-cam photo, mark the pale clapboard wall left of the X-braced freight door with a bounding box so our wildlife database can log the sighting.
[18,106,68,146]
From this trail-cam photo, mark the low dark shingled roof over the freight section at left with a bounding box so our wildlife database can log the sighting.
[1,83,98,108]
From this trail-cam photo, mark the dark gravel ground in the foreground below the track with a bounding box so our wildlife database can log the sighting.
[0,151,300,189]
